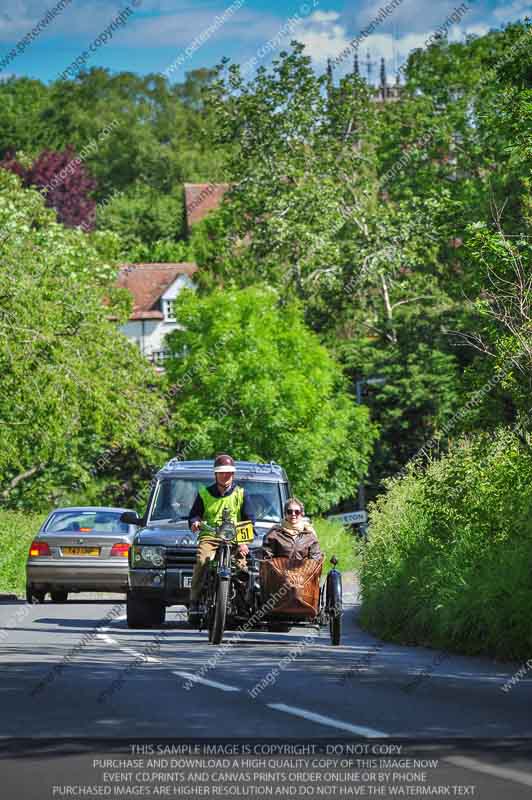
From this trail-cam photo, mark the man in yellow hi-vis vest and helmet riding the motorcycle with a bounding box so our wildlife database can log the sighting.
[188,453,255,614]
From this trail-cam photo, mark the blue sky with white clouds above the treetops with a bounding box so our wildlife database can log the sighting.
[0,0,532,82]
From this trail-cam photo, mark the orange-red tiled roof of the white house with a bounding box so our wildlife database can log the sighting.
[117,262,198,320]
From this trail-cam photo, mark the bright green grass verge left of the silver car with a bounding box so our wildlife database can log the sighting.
[0,511,44,597]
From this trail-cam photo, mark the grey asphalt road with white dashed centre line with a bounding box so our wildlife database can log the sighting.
[0,586,532,800]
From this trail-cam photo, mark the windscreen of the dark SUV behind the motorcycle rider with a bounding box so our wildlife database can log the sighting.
[149,478,282,522]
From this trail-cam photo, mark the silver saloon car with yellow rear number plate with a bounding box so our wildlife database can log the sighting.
[26,506,137,603]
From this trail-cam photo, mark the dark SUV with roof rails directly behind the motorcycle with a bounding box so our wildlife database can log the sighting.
[122,459,290,628]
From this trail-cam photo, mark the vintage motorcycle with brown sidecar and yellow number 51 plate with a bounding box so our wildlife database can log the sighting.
[191,509,342,646]
